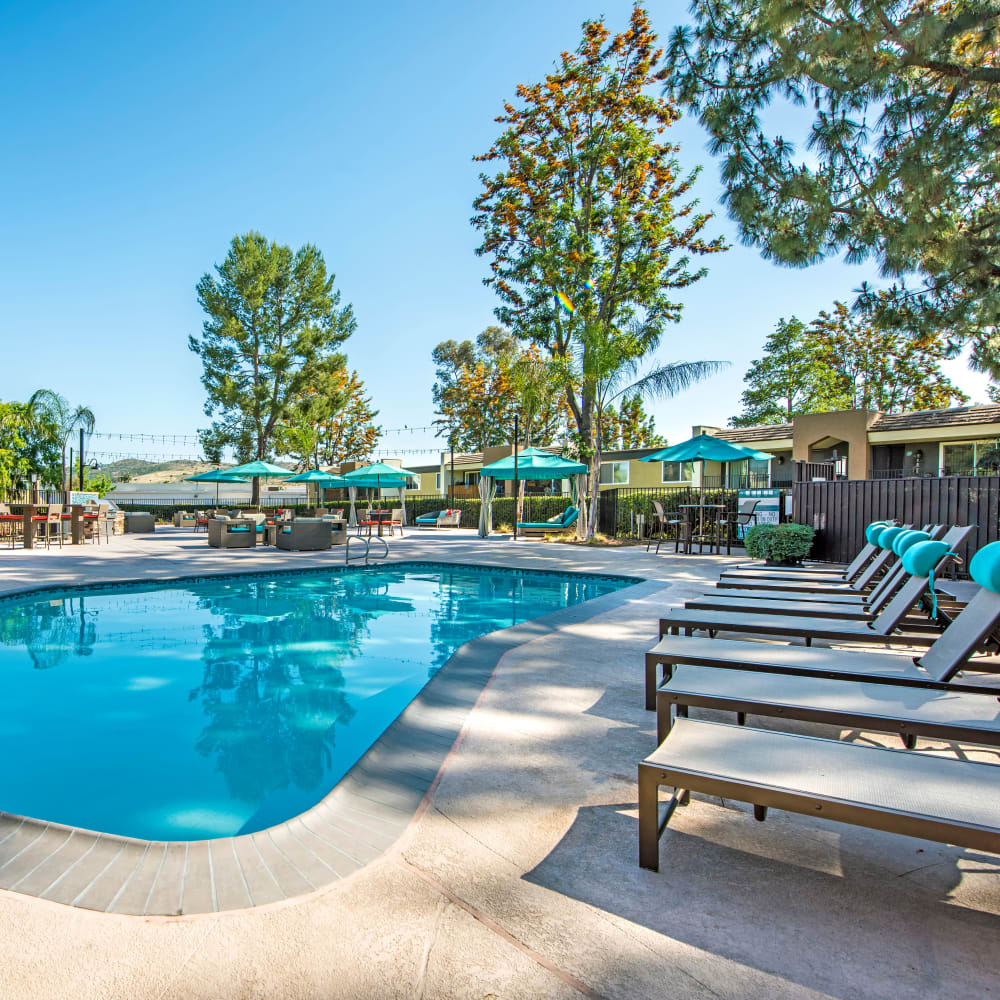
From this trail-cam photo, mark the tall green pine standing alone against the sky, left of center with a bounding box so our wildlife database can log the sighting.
[189,232,357,503]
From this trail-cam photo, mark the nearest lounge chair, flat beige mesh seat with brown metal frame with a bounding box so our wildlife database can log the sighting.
[639,719,1000,871]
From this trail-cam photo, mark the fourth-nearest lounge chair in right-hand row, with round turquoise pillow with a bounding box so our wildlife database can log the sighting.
[660,527,973,646]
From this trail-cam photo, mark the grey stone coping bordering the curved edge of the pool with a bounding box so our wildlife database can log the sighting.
[0,559,670,918]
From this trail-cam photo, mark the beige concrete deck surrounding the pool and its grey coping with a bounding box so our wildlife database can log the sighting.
[0,531,1000,998]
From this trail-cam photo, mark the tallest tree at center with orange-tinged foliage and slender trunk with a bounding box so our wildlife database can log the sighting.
[472,6,725,540]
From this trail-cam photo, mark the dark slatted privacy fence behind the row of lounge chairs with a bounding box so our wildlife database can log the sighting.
[792,476,1000,562]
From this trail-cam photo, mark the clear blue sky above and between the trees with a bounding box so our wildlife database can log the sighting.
[0,0,985,464]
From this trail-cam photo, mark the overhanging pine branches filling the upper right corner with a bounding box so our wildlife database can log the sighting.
[663,0,1000,340]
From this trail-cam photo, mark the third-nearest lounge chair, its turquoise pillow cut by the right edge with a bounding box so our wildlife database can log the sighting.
[645,542,1000,711]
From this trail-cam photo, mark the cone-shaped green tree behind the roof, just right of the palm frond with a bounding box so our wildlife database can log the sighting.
[729,316,842,427]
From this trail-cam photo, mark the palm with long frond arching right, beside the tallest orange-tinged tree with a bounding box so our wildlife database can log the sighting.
[572,322,729,538]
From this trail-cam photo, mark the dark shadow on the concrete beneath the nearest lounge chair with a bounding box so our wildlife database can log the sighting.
[525,799,1000,998]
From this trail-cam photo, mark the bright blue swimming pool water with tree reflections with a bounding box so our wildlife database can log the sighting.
[0,564,633,840]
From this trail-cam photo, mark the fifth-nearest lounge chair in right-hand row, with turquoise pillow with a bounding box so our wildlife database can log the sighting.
[684,528,952,621]
